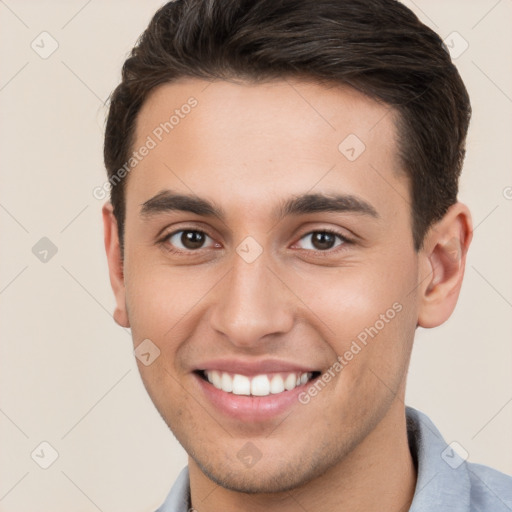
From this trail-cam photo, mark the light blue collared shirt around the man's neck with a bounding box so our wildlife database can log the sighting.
[156,407,512,512]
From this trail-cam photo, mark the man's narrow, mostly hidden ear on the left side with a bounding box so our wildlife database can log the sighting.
[102,203,130,327]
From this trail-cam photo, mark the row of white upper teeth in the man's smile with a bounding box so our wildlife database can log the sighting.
[204,370,313,396]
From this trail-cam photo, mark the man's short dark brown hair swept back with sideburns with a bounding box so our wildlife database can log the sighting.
[104,0,471,254]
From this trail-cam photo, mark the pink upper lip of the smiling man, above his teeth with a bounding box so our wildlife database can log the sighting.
[196,359,319,376]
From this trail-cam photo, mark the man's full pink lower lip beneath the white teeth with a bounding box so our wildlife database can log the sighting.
[194,374,312,423]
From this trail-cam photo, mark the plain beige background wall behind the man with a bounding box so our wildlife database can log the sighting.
[0,0,512,512]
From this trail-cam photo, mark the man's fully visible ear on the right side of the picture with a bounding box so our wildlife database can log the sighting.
[418,203,473,328]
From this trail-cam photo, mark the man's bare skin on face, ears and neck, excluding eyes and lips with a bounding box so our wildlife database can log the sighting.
[103,79,472,512]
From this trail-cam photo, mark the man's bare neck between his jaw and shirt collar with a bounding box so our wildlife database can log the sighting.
[189,400,416,512]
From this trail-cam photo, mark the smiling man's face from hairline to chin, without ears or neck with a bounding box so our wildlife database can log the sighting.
[116,80,424,492]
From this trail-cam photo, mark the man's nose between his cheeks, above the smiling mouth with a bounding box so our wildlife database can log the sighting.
[210,248,294,348]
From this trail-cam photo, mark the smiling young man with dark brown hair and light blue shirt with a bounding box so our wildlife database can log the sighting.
[103,0,512,512]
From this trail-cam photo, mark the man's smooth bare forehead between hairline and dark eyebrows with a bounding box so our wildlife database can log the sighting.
[127,79,407,220]
